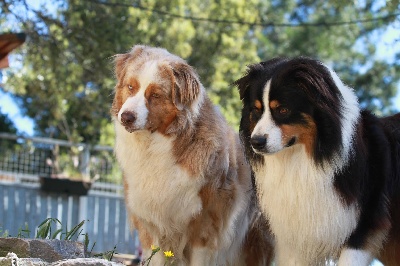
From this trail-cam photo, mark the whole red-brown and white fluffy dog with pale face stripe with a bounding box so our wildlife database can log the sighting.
[111,45,273,265]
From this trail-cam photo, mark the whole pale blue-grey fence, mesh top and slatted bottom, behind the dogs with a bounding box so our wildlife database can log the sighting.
[0,133,140,255]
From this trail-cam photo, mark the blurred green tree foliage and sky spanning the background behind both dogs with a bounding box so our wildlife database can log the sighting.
[0,0,400,144]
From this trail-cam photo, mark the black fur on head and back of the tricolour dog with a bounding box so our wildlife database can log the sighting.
[234,57,400,263]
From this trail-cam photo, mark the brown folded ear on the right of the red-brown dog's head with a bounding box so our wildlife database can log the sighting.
[171,63,201,110]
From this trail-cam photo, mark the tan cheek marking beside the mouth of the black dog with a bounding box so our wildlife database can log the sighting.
[280,114,317,157]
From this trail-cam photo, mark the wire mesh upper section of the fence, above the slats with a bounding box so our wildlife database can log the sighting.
[0,132,121,184]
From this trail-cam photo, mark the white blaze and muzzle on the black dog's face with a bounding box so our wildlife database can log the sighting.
[251,80,284,153]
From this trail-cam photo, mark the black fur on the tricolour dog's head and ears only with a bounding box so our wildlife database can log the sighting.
[238,57,345,163]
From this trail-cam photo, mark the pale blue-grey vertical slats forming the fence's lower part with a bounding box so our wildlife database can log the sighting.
[0,177,139,254]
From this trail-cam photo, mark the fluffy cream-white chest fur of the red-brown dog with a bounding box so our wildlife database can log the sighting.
[115,123,204,234]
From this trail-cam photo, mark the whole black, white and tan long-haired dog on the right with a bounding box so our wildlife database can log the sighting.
[235,57,400,265]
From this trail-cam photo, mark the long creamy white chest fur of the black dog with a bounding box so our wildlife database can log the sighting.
[255,145,359,265]
